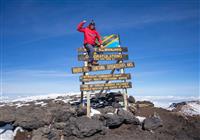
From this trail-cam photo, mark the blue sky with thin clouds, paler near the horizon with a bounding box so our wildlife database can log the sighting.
[0,0,200,96]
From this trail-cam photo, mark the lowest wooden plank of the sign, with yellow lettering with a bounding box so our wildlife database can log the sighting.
[80,82,132,91]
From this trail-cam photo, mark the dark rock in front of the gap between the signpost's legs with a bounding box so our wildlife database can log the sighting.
[103,114,124,128]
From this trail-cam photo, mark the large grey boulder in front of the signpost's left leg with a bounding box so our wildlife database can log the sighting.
[70,116,105,138]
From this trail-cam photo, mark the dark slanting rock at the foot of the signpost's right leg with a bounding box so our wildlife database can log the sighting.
[117,108,140,125]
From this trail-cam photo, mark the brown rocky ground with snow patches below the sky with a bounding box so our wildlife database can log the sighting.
[0,96,200,140]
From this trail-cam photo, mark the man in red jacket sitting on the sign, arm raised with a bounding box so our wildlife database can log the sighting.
[77,20,103,65]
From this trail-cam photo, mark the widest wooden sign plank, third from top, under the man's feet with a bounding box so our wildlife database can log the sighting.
[72,62,135,73]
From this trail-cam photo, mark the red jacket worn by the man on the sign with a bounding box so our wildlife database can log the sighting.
[77,22,102,45]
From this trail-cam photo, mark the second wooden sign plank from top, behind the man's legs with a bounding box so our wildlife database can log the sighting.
[78,54,128,61]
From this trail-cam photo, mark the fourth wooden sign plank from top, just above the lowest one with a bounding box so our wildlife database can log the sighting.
[80,74,131,82]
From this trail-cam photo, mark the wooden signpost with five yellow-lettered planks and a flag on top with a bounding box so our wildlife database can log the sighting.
[72,35,134,117]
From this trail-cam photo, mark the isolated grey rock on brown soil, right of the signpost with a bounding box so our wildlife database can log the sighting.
[143,116,163,130]
